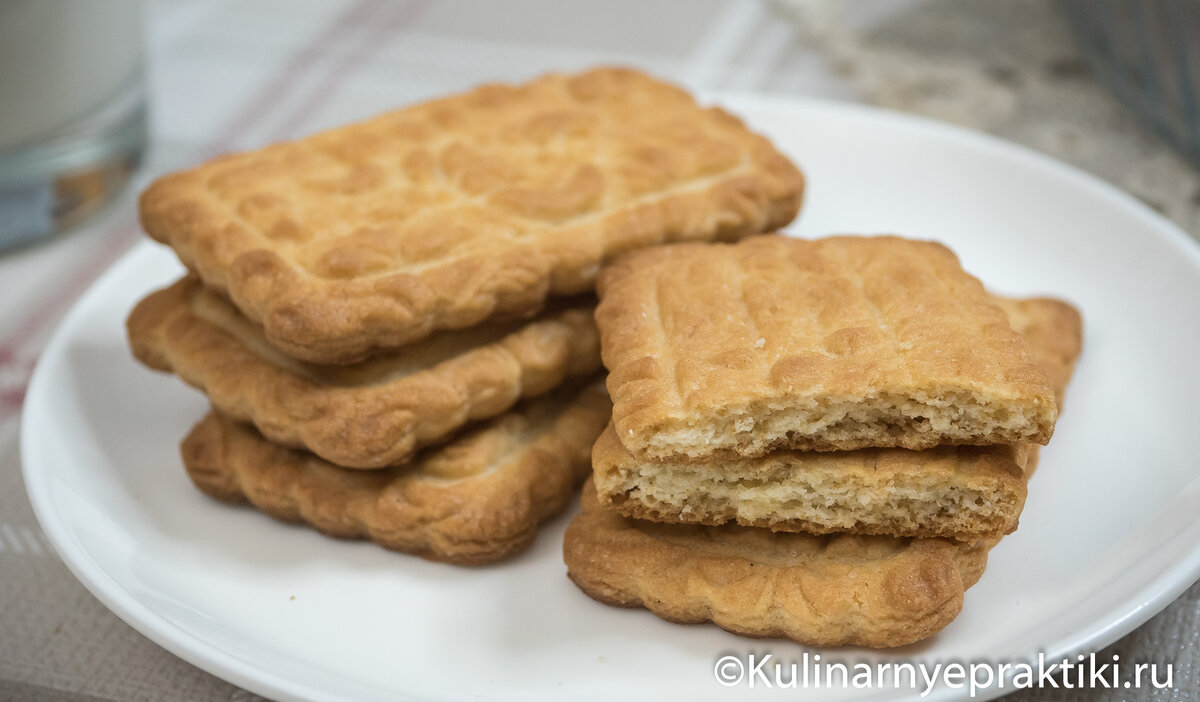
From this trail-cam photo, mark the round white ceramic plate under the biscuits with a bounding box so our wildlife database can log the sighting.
[22,97,1200,701]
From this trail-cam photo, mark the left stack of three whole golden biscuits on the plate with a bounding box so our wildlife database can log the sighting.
[127,68,804,563]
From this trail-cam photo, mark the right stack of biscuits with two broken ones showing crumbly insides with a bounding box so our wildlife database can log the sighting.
[564,235,1081,647]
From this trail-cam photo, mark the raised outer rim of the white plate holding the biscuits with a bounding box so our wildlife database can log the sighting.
[19,91,1200,702]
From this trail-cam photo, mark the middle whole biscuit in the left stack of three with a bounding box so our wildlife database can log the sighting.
[127,278,600,468]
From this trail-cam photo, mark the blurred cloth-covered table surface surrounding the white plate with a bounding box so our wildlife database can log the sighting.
[0,0,1200,702]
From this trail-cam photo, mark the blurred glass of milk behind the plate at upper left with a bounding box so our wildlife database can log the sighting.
[0,0,146,250]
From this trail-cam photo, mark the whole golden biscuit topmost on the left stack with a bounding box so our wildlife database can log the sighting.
[140,68,804,364]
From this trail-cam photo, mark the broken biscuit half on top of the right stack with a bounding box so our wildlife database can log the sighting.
[596,236,1057,461]
